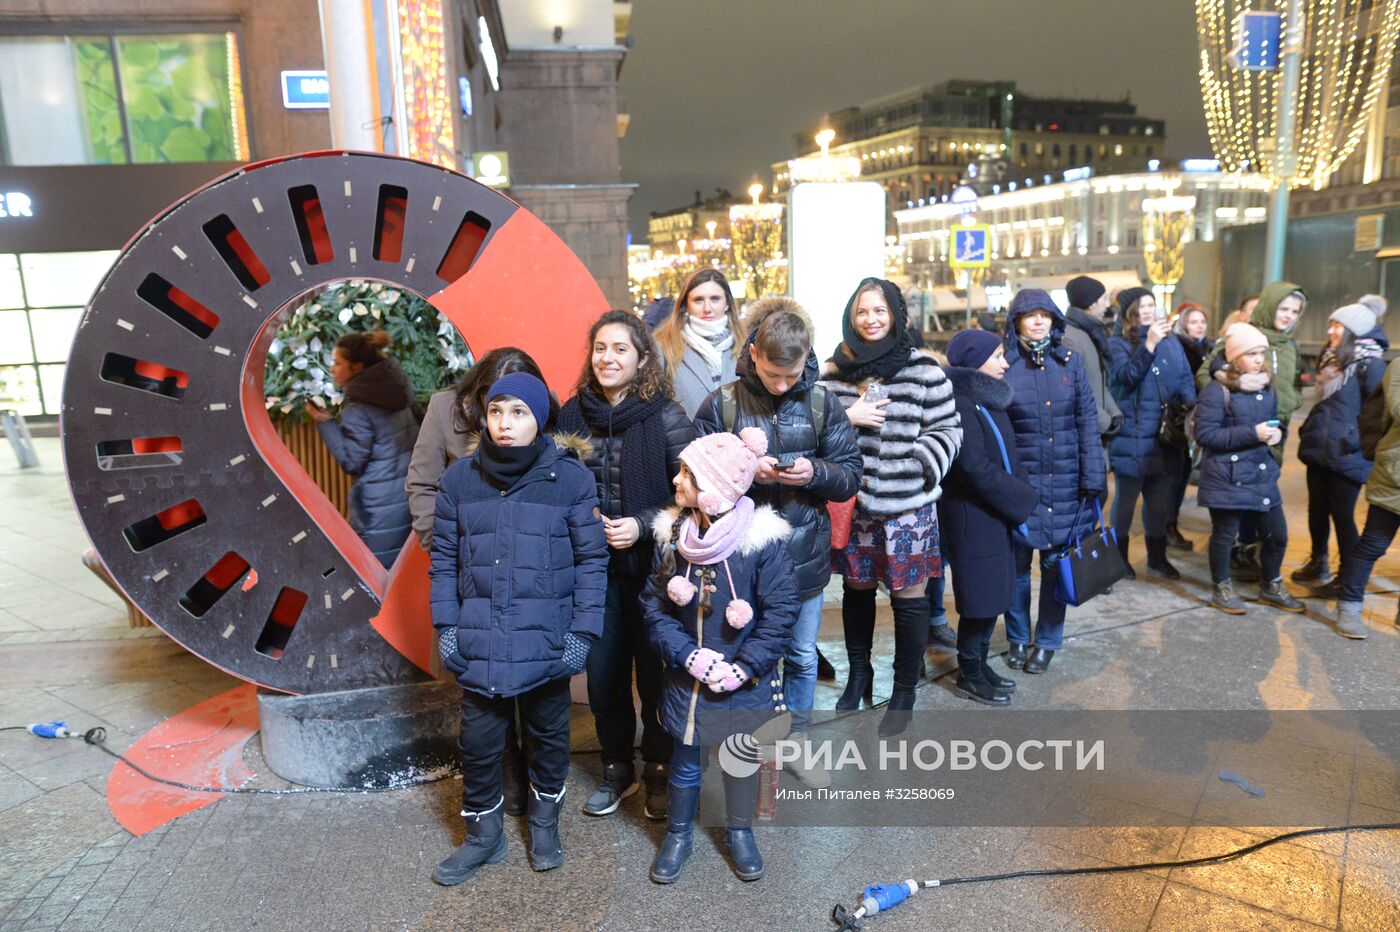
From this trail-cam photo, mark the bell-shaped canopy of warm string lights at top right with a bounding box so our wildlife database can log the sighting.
[1196,0,1400,188]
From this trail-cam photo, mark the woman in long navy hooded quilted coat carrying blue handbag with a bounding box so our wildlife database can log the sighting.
[1005,288,1106,673]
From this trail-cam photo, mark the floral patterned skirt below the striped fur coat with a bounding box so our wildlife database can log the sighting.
[832,504,944,591]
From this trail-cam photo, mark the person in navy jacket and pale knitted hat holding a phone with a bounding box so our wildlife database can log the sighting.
[1196,323,1303,614]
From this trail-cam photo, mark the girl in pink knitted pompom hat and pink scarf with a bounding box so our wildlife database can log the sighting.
[641,427,798,883]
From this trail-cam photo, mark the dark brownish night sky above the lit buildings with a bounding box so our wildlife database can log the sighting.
[620,0,1210,242]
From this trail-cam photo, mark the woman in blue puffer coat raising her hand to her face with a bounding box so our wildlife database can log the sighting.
[1109,288,1196,579]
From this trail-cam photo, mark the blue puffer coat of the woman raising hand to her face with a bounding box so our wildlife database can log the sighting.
[1109,327,1196,479]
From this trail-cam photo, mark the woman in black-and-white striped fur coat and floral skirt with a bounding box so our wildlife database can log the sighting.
[827,278,962,727]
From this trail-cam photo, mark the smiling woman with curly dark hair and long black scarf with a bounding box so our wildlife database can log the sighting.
[559,311,694,819]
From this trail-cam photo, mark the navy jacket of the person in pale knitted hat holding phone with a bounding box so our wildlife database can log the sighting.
[1194,378,1282,511]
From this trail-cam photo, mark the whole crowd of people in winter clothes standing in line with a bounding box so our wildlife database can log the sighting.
[312,269,1400,883]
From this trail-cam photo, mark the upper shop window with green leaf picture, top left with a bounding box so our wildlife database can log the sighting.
[0,32,249,165]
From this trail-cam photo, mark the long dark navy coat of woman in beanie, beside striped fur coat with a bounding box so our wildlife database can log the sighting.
[938,367,1039,619]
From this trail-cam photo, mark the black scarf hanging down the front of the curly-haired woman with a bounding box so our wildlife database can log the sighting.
[557,388,672,518]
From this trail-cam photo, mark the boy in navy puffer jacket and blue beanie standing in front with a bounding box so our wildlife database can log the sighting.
[430,372,608,884]
